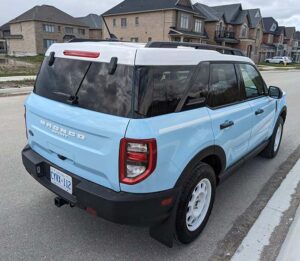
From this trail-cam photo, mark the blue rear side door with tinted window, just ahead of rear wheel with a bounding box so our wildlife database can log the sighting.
[209,63,253,167]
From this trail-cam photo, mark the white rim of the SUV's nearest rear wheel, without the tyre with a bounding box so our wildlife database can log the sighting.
[186,179,212,232]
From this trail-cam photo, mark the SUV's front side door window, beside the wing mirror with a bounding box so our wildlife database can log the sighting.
[239,64,265,99]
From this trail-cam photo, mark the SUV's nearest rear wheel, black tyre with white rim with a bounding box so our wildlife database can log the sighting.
[176,163,216,244]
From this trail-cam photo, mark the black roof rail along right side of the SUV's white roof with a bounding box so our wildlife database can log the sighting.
[145,42,245,56]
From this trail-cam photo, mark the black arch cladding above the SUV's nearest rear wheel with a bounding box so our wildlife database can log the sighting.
[175,146,226,187]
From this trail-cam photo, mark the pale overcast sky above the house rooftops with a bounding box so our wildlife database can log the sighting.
[0,0,300,30]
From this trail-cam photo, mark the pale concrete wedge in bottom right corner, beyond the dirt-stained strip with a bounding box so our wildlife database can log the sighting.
[276,204,300,261]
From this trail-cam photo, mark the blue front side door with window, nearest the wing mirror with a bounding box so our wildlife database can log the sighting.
[238,64,276,150]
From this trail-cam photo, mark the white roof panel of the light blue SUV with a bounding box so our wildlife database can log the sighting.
[46,42,253,66]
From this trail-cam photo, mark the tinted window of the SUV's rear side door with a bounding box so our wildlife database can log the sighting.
[209,63,240,107]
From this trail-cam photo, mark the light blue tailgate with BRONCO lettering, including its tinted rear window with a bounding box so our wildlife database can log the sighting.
[26,54,133,191]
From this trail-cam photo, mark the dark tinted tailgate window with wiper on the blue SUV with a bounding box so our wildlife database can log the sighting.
[34,57,134,117]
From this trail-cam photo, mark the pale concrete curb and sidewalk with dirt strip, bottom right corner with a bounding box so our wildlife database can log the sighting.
[231,160,300,261]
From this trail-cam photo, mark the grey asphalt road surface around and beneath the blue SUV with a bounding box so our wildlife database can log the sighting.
[0,71,300,261]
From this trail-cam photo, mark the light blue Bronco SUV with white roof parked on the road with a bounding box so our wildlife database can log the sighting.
[22,42,287,246]
